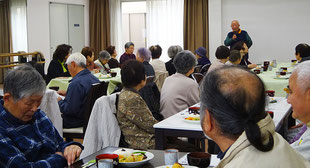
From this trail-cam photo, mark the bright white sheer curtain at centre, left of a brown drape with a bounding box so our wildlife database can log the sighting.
[146,0,184,61]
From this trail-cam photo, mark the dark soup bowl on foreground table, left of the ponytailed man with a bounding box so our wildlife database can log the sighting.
[187,152,211,168]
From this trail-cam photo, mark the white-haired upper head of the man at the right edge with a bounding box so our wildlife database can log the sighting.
[293,61,310,92]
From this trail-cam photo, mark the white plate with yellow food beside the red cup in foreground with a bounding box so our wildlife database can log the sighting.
[113,148,154,167]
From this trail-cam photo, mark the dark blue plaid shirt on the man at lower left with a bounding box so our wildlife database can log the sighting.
[0,100,83,168]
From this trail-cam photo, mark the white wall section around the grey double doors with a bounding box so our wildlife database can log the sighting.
[27,0,89,70]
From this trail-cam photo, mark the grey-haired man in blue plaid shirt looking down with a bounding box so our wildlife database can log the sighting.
[0,65,83,168]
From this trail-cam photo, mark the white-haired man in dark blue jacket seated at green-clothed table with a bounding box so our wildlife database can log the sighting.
[58,53,100,128]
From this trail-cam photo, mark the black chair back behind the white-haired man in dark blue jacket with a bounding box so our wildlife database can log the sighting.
[83,81,109,133]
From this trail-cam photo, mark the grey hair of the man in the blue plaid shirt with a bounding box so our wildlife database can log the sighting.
[3,65,46,102]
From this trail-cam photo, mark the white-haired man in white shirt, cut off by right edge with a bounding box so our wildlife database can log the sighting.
[287,61,310,161]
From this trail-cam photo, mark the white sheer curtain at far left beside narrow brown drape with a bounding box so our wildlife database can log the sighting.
[10,0,28,52]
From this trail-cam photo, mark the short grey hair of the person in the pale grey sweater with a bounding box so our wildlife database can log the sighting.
[173,50,196,74]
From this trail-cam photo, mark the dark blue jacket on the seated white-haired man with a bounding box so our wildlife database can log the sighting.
[58,69,100,128]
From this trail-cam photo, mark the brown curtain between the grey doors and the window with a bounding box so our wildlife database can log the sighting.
[89,0,111,58]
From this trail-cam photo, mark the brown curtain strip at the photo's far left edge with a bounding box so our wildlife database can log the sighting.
[0,0,12,83]
